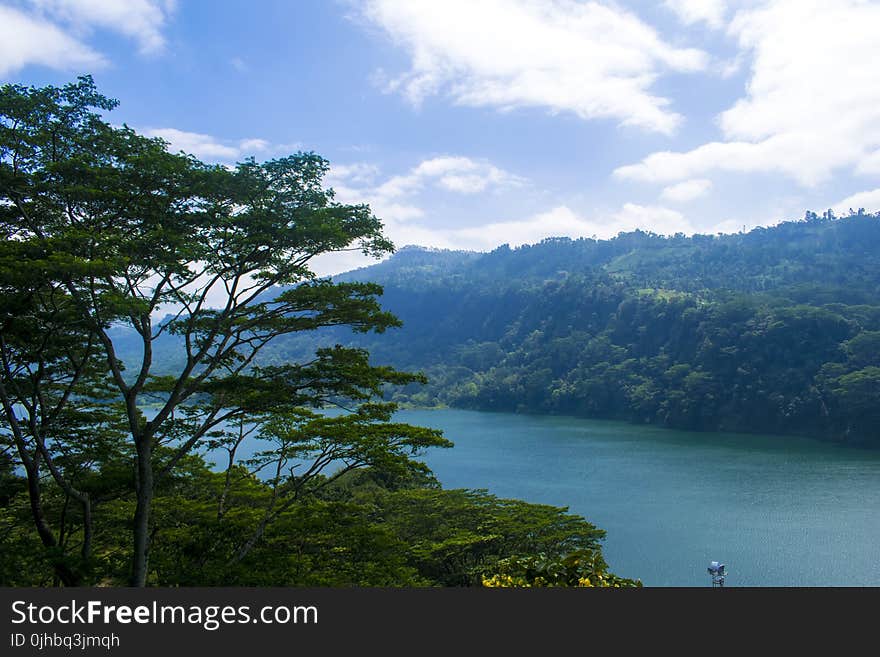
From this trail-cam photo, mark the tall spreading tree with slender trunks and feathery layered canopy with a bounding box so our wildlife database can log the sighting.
[0,77,448,585]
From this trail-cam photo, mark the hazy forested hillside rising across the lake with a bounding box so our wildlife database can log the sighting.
[271,213,880,446]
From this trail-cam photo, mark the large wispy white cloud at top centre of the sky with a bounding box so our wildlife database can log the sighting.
[363,0,708,135]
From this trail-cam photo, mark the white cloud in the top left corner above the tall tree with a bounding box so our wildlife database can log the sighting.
[0,6,106,75]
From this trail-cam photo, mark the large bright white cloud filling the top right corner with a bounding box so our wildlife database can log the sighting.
[615,0,880,186]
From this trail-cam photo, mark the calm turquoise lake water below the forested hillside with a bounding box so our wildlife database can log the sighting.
[398,410,880,586]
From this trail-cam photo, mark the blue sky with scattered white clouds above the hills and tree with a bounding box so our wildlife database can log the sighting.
[0,0,880,273]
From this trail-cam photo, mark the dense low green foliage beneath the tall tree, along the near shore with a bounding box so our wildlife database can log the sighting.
[0,458,632,587]
